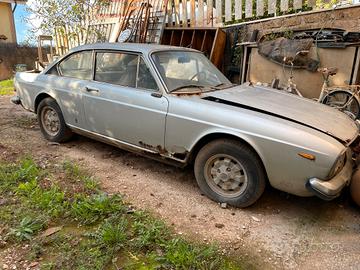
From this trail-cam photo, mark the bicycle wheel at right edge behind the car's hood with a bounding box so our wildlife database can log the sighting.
[321,90,360,119]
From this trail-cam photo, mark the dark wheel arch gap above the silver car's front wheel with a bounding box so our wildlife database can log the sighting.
[188,132,268,178]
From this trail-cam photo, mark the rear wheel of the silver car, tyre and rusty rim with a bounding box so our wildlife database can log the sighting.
[37,97,73,143]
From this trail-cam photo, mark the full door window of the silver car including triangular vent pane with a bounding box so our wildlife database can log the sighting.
[95,52,158,91]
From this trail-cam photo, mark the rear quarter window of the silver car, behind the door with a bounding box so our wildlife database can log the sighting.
[58,51,92,80]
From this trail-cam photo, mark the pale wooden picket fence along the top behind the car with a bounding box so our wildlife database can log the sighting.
[55,0,352,54]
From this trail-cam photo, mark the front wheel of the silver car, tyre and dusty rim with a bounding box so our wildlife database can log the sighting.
[194,139,266,208]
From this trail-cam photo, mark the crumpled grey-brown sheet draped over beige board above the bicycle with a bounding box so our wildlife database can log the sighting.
[258,37,319,71]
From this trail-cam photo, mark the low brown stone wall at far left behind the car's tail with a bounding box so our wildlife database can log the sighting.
[0,43,37,80]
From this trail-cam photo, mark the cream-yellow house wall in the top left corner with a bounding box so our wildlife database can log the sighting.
[0,2,16,43]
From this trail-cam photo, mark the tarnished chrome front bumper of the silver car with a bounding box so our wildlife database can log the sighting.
[306,151,354,201]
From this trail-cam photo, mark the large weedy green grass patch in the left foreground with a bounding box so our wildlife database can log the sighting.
[0,158,245,270]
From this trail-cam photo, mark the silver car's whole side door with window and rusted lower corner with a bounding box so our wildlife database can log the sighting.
[83,51,168,152]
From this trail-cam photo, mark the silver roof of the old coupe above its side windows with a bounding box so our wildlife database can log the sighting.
[69,42,197,54]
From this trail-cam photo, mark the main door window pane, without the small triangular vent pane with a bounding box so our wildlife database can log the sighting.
[95,52,138,87]
